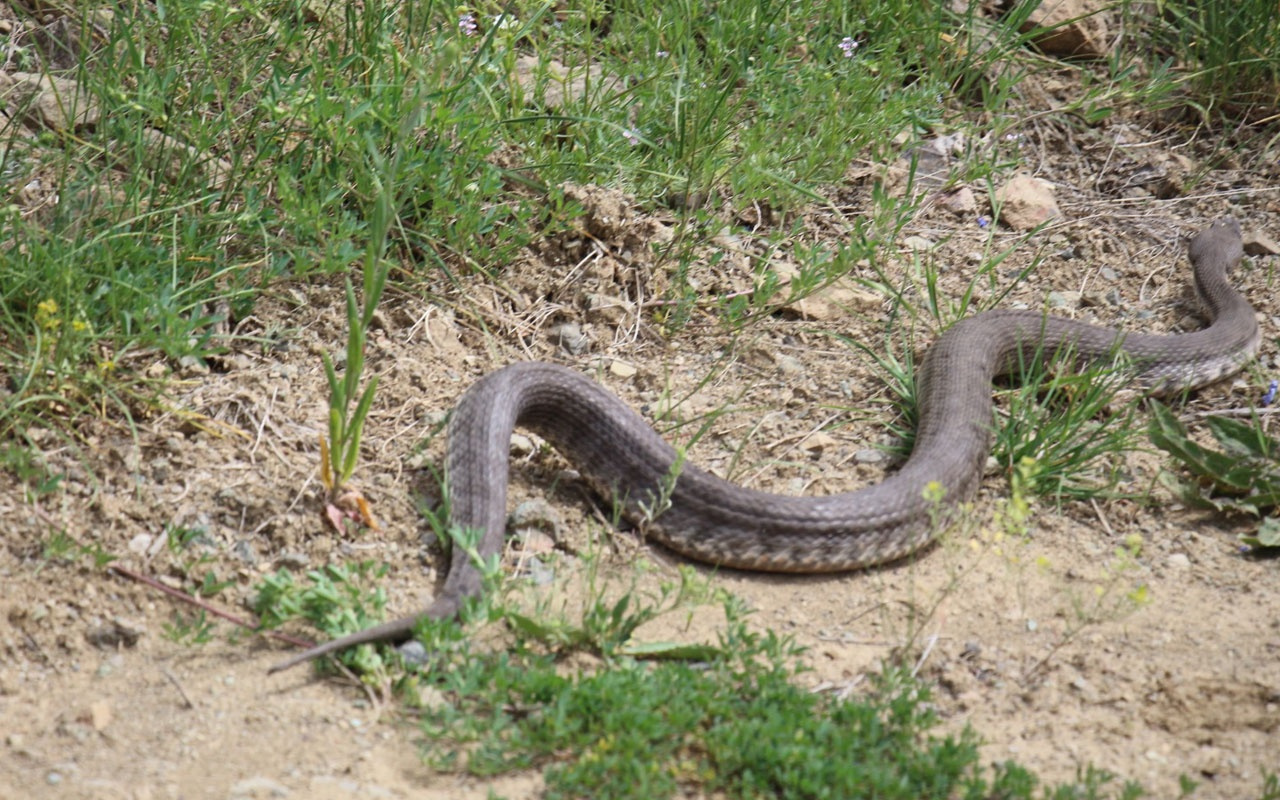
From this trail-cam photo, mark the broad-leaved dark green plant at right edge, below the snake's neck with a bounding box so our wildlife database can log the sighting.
[1149,403,1280,553]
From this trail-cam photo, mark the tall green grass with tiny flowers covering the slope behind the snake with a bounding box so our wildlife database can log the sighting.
[0,0,1100,430]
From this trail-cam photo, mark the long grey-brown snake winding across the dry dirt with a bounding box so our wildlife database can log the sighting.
[271,218,1261,672]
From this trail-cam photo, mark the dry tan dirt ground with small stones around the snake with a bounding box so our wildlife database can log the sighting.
[0,68,1280,799]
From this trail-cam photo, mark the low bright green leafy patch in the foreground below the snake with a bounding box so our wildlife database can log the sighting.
[416,586,1138,800]
